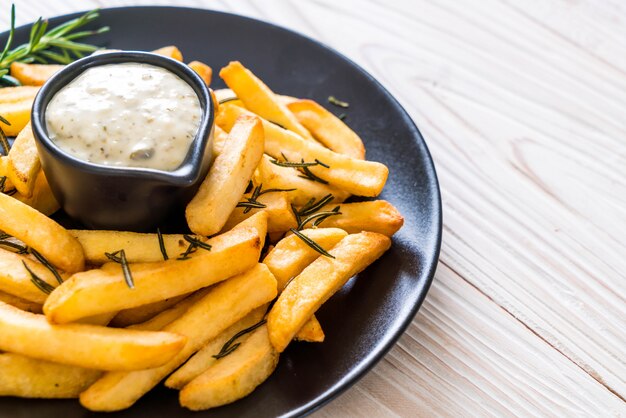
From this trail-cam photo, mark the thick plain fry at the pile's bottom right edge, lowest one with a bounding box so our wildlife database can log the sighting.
[179,325,279,411]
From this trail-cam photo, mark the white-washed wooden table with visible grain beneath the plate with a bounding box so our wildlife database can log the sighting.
[6,0,626,418]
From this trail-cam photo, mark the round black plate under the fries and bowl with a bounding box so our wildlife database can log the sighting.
[0,7,441,418]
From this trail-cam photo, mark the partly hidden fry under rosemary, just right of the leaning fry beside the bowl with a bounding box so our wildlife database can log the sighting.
[222,192,298,233]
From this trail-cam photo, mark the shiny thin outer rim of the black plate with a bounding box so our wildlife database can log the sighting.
[0,5,443,418]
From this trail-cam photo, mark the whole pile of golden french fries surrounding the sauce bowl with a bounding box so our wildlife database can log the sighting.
[0,47,403,411]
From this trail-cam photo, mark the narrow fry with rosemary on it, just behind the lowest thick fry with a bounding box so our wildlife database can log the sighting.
[165,305,267,389]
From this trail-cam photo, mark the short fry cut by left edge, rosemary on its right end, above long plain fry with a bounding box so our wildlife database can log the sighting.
[0,249,69,304]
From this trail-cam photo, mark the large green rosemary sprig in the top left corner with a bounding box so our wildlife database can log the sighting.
[0,4,109,85]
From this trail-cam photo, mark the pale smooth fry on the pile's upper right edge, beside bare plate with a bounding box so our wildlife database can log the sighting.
[287,100,365,160]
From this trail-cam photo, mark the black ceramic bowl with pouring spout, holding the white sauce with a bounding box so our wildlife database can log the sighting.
[31,51,214,231]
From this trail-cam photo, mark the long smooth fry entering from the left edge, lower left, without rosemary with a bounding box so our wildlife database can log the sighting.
[0,303,186,370]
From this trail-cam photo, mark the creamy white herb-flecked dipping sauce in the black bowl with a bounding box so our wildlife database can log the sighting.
[46,63,202,171]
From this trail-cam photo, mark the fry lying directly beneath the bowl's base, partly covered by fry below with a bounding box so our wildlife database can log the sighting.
[69,229,190,265]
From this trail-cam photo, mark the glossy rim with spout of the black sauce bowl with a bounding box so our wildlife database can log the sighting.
[31,51,215,187]
